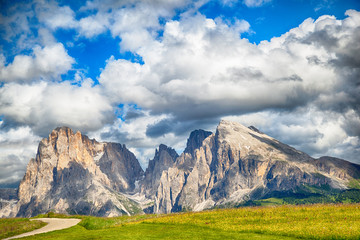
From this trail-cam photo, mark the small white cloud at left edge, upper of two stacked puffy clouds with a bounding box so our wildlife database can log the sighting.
[0,43,75,82]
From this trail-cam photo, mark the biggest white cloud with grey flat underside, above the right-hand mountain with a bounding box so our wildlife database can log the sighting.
[99,11,348,119]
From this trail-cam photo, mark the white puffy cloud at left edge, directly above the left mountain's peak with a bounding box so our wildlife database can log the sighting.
[0,81,114,136]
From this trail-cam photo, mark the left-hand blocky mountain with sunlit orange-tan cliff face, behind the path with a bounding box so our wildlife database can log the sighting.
[17,127,143,217]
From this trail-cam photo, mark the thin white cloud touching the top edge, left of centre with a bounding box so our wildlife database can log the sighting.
[77,0,195,51]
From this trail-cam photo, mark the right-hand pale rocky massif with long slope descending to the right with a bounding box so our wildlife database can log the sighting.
[154,121,360,213]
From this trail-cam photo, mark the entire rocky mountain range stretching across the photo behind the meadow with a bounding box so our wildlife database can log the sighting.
[0,120,360,217]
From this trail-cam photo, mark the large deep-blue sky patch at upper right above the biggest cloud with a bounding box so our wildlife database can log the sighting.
[200,0,360,43]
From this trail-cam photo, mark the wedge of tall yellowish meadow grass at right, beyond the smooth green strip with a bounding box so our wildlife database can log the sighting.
[147,204,360,239]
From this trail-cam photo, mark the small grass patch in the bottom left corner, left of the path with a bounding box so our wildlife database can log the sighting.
[0,218,46,239]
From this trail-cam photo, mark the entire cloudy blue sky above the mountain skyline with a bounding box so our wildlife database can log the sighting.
[0,0,360,187]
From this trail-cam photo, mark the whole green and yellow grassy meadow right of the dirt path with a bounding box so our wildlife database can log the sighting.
[0,204,360,240]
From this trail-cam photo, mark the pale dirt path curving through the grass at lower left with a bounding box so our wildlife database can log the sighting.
[5,218,81,240]
